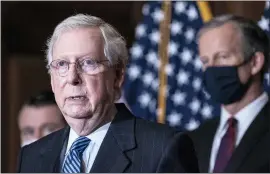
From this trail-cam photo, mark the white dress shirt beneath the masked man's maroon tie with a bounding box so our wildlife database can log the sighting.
[209,92,268,172]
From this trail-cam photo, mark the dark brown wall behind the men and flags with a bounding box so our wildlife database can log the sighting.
[1,1,264,172]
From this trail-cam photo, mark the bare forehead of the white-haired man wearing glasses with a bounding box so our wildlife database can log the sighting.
[52,27,104,60]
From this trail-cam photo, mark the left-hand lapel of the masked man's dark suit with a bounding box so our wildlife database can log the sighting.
[198,117,219,173]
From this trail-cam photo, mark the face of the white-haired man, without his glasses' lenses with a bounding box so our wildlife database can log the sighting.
[51,28,119,121]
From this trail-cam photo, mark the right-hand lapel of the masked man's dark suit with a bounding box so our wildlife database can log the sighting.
[225,102,270,172]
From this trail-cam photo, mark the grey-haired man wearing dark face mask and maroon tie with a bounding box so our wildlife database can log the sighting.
[190,15,270,173]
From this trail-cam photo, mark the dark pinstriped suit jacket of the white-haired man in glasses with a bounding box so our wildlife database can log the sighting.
[17,104,198,173]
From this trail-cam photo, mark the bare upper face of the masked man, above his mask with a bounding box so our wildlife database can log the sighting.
[199,23,251,83]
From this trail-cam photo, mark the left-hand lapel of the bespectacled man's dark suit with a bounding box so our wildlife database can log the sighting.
[40,127,69,173]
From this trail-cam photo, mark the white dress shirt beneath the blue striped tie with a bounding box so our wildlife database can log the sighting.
[63,122,111,173]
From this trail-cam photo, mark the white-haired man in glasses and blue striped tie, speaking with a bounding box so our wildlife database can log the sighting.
[18,14,198,173]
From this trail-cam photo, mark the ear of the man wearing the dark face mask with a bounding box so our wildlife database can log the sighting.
[251,52,265,75]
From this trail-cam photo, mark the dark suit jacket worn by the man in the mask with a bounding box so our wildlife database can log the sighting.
[189,102,270,173]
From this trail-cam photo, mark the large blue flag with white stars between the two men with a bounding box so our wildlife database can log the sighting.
[124,1,269,131]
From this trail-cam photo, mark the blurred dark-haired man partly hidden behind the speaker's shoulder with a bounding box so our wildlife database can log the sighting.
[18,91,66,146]
